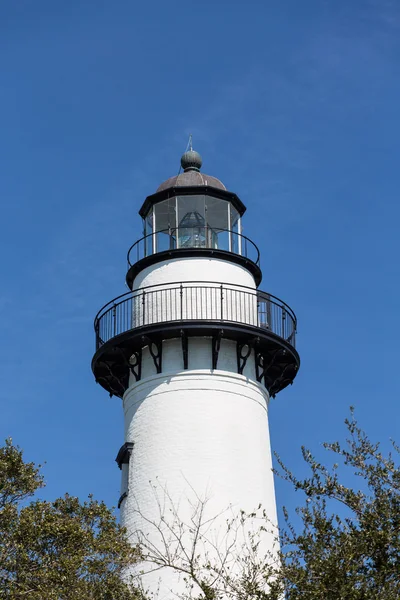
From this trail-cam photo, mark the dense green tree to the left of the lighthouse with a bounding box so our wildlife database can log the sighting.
[0,440,138,600]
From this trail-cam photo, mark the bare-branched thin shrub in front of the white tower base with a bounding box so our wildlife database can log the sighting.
[133,483,282,600]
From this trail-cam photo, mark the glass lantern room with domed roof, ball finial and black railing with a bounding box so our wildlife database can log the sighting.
[127,150,261,287]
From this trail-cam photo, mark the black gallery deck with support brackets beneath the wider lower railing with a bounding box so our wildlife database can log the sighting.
[92,320,300,397]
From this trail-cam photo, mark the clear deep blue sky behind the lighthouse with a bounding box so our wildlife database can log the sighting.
[0,0,400,506]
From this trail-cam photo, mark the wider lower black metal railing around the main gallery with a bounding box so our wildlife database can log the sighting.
[94,281,297,350]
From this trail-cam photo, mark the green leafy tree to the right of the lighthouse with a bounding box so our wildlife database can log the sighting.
[278,412,400,600]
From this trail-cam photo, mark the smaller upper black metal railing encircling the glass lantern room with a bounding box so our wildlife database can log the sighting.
[128,227,260,267]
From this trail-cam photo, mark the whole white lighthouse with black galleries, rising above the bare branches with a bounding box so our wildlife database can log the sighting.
[92,150,300,597]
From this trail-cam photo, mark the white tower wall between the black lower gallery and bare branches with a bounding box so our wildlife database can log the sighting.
[123,366,276,530]
